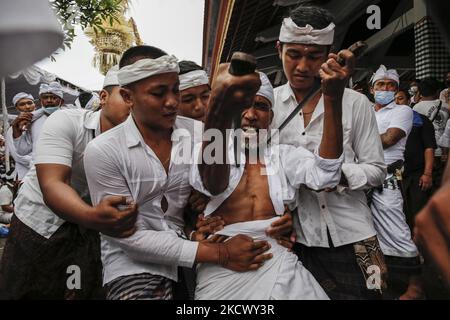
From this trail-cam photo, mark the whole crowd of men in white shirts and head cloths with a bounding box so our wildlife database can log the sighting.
[0,6,450,300]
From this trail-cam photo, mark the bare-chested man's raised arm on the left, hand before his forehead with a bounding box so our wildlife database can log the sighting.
[198,64,261,195]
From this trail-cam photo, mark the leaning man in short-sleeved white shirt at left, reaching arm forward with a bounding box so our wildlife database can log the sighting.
[0,65,136,299]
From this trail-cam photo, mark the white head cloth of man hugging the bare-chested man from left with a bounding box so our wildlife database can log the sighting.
[118,55,180,86]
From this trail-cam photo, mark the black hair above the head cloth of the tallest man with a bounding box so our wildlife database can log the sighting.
[289,5,334,29]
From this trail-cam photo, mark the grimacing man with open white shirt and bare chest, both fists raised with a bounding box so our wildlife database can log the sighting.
[191,66,343,300]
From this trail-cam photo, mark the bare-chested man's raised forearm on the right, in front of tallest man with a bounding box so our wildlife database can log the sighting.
[319,97,343,159]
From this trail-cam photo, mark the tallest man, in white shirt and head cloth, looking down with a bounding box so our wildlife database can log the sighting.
[273,6,386,299]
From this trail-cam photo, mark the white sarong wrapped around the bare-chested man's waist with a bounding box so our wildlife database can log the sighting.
[195,217,328,300]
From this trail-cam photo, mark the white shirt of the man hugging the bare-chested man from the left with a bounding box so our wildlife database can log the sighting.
[84,116,202,284]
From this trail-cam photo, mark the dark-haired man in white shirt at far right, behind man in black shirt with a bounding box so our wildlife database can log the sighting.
[414,78,449,190]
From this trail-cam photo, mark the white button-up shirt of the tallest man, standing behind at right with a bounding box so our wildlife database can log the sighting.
[272,84,386,248]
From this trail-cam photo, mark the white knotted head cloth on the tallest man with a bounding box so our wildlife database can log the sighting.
[280,18,336,46]
